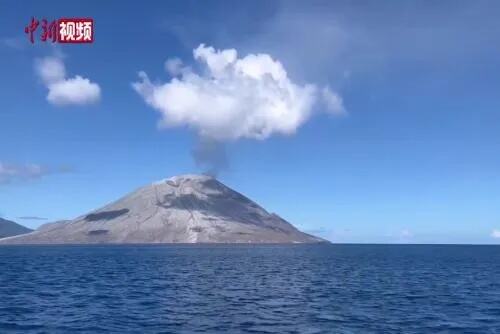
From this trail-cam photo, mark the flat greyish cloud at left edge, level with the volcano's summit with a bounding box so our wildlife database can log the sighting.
[0,162,71,184]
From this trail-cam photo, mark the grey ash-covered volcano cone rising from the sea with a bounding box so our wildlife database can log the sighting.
[0,175,324,243]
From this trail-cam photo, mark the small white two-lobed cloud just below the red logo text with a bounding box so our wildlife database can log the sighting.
[35,57,101,106]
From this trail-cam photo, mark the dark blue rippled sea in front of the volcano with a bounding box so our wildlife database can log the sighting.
[0,245,500,333]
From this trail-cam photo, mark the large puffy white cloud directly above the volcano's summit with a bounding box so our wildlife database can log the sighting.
[132,44,343,141]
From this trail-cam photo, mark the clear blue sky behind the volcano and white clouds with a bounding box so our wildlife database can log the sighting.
[0,1,500,243]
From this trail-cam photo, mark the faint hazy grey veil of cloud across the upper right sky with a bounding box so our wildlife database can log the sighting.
[162,1,500,87]
